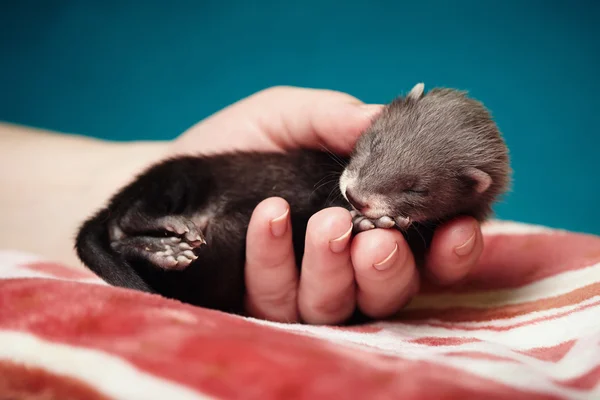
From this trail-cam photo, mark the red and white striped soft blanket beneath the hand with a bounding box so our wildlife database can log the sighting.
[0,222,600,400]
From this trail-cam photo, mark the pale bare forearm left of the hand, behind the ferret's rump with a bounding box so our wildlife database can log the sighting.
[0,123,167,265]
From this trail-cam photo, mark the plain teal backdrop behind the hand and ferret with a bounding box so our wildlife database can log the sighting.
[0,0,600,234]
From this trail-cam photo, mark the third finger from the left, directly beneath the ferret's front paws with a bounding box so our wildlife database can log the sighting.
[351,229,419,318]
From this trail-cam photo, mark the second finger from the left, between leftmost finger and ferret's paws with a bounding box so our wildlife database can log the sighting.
[298,207,355,324]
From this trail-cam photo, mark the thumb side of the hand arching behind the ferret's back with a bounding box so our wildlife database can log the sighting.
[178,86,382,154]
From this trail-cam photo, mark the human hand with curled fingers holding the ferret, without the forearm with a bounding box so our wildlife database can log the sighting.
[172,87,483,324]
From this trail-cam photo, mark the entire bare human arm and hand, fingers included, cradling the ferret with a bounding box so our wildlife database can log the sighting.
[0,87,483,324]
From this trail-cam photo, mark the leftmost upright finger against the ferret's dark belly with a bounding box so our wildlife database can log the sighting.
[245,197,298,322]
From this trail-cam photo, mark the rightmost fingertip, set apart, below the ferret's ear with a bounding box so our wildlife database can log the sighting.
[425,217,483,285]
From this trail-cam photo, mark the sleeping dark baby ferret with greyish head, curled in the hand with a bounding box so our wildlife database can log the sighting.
[76,84,510,313]
